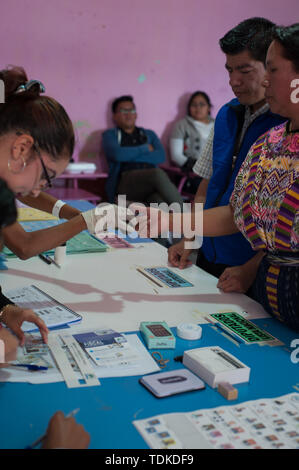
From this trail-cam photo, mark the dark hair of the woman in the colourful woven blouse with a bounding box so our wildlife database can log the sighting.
[273,23,299,72]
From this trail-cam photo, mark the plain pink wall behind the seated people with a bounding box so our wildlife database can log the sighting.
[0,0,298,169]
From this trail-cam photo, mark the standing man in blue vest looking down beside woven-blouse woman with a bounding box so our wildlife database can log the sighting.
[168,18,285,277]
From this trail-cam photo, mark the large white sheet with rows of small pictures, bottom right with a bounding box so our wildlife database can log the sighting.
[133,393,299,450]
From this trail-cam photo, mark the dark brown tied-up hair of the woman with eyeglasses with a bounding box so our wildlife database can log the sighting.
[0,67,75,160]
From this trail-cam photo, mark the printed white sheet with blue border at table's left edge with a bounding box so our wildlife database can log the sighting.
[5,285,82,332]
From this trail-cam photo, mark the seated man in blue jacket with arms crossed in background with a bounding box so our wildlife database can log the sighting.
[103,96,183,205]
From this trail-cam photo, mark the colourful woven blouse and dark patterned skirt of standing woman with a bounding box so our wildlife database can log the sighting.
[230,123,299,325]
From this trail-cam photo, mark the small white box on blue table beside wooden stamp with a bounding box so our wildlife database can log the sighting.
[183,346,250,388]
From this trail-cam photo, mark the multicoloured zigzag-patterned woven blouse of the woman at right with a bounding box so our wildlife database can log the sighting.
[230,123,299,252]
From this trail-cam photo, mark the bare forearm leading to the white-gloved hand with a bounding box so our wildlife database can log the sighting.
[3,215,87,260]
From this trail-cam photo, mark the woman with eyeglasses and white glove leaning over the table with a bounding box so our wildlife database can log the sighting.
[0,67,131,259]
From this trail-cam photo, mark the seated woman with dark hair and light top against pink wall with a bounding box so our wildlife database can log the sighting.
[169,91,214,194]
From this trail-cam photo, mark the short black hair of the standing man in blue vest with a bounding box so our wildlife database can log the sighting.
[219,17,275,63]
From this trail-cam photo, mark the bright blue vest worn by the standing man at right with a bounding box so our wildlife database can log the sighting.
[202,98,285,266]
